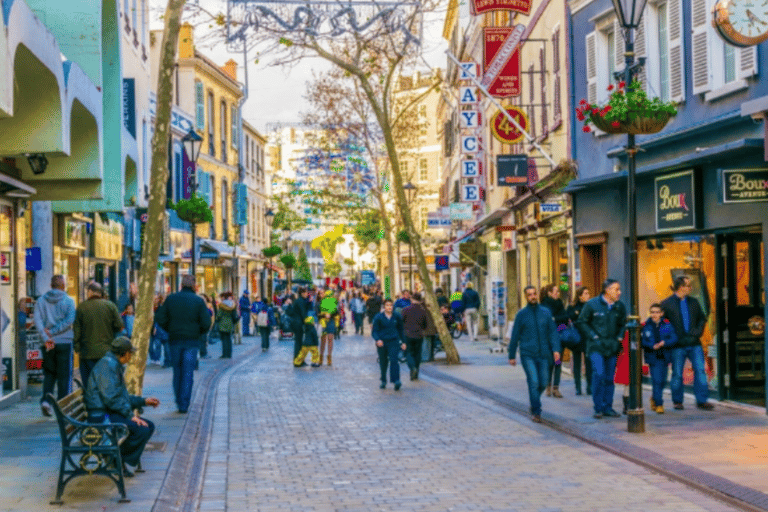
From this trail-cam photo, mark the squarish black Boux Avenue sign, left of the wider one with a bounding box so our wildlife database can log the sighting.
[654,171,696,231]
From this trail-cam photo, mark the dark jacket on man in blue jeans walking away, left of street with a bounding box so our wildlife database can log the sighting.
[155,288,211,347]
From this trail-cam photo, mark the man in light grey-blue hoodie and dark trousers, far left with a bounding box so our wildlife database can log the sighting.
[34,274,77,416]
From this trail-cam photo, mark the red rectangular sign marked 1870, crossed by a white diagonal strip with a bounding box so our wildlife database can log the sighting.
[480,24,525,98]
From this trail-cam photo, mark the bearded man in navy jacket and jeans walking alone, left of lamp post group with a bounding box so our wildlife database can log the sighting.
[509,286,560,423]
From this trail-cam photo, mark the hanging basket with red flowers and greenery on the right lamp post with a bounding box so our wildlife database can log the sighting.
[576,79,677,135]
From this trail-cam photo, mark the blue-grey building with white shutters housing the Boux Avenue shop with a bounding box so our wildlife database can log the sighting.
[566,0,768,405]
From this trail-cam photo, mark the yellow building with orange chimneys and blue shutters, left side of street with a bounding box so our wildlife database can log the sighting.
[176,24,244,293]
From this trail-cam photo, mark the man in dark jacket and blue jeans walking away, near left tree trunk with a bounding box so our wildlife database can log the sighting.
[155,274,211,413]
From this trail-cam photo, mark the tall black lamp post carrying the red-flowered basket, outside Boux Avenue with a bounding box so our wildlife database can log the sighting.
[613,0,646,433]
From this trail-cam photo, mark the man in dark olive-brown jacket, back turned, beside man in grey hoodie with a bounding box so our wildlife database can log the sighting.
[72,281,123,388]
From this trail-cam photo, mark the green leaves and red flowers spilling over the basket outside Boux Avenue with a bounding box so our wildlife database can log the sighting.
[576,79,677,132]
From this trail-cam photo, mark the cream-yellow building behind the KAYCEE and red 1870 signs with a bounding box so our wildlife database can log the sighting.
[440,0,576,336]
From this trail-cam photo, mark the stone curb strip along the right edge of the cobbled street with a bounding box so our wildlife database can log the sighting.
[422,366,768,512]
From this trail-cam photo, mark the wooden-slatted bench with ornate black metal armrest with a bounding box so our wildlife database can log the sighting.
[48,388,131,505]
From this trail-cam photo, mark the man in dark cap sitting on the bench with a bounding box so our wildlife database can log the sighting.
[85,336,160,476]
